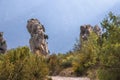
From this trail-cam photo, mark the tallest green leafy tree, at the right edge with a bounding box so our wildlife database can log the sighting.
[98,12,120,80]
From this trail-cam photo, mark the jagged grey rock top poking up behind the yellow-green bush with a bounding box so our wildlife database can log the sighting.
[80,24,101,41]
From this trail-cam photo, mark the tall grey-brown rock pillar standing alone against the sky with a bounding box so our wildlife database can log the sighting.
[27,19,48,55]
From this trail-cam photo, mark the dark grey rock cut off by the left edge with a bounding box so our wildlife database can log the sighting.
[0,32,7,53]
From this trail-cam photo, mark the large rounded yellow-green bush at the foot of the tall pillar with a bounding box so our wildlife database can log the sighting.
[0,47,48,80]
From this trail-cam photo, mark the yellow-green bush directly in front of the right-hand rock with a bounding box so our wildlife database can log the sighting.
[73,32,100,76]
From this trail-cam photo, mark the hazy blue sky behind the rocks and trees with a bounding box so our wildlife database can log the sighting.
[0,0,120,53]
